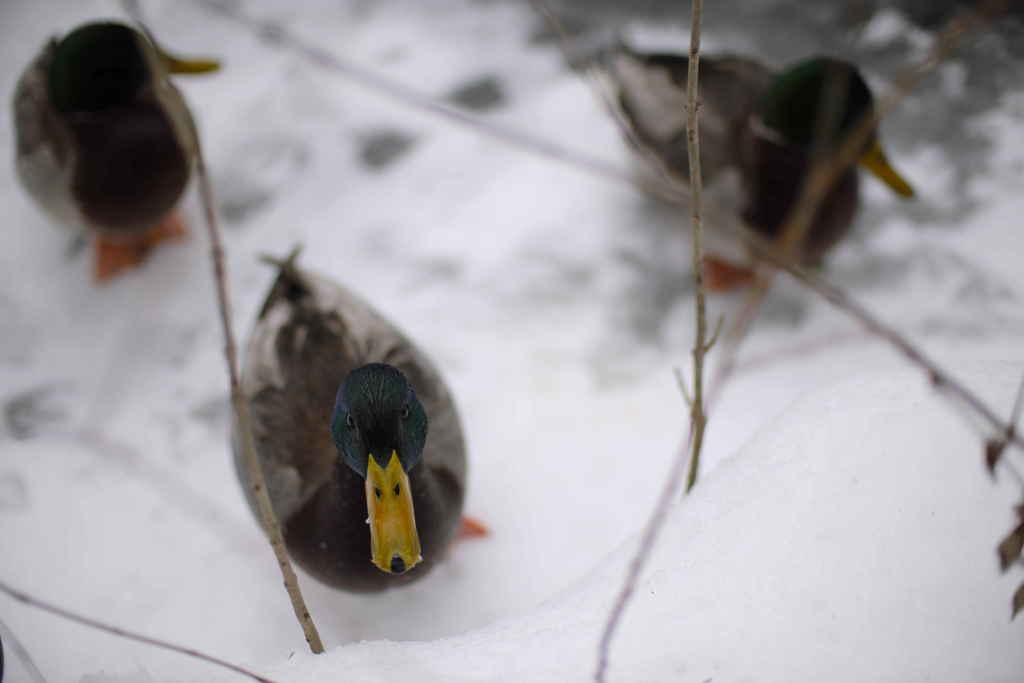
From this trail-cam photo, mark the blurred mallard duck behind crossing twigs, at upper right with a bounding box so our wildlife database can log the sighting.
[601,47,913,289]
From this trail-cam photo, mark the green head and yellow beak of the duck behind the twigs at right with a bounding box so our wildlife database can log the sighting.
[759,57,913,198]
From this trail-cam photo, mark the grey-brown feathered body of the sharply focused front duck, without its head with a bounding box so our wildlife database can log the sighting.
[233,263,466,591]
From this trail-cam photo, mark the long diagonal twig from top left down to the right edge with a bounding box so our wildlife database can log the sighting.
[194,0,1024,464]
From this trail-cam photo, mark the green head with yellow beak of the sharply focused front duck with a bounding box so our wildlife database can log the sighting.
[331,362,427,573]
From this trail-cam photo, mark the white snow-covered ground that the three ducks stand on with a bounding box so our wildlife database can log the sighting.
[0,0,1024,683]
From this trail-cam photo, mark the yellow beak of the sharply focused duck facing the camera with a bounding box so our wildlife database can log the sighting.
[367,452,423,573]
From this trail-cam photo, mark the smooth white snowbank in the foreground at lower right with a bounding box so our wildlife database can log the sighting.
[253,362,1024,682]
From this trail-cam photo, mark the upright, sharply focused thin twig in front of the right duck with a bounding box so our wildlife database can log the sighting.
[686,0,708,494]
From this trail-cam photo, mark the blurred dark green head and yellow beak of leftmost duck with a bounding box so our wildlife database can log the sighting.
[49,22,219,114]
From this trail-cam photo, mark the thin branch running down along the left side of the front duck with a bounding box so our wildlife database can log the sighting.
[123,0,324,654]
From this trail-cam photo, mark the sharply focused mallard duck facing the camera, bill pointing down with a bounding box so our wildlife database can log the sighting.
[233,253,484,592]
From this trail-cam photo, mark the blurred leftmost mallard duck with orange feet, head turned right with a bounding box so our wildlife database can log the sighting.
[12,22,217,281]
